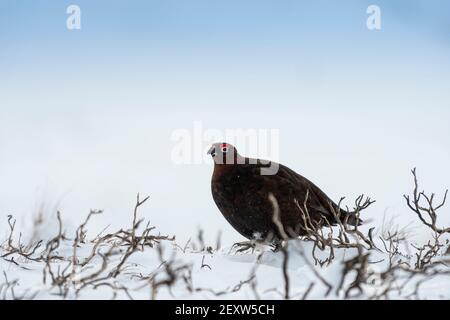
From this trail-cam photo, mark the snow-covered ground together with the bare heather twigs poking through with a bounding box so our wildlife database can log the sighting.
[0,198,450,299]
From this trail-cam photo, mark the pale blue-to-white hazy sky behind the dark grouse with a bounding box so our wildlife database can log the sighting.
[0,0,450,238]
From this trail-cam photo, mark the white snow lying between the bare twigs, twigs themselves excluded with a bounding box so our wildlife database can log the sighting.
[0,212,450,300]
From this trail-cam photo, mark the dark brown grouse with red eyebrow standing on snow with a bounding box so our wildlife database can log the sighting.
[207,142,374,246]
